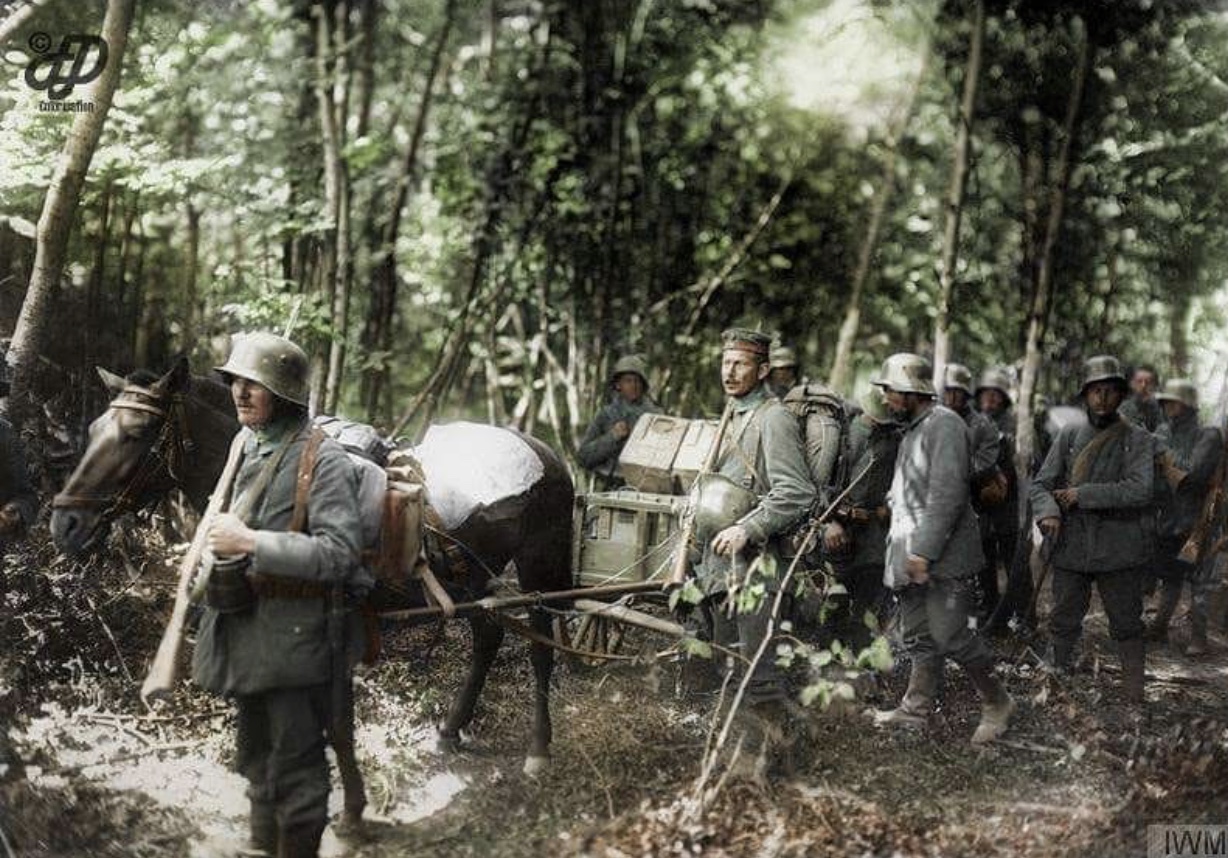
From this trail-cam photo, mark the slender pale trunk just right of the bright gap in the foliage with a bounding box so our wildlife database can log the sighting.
[933,0,985,390]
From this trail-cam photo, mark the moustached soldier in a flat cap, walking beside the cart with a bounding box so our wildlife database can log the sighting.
[695,329,814,721]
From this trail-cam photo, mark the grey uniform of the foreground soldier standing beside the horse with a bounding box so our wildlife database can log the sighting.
[193,419,372,841]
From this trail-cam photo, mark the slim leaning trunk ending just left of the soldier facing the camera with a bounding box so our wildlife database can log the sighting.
[1016,20,1092,474]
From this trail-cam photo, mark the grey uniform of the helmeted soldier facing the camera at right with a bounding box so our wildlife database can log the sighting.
[1032,415,1154,667]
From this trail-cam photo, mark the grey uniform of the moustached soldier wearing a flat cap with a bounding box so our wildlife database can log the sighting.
[695,384,814,703]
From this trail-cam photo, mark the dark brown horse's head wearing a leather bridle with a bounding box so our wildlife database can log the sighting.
[52,358,237,556]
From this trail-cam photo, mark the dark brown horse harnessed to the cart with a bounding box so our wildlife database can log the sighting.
[52,357,575,821]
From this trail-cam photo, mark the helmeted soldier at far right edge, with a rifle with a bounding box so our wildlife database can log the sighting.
[1147,378,1223,655]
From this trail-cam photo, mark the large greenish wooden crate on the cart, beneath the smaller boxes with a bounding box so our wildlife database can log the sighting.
[572,491,686,587]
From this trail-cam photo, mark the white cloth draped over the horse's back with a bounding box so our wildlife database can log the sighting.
[410,422,545,530]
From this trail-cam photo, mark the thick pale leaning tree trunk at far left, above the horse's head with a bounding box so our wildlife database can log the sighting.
[10,0,136,425]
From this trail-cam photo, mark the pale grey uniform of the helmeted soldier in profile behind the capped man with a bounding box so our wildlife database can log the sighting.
[884,405,992,669]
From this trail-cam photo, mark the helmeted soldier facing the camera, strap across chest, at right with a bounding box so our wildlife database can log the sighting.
[1032,355,1154,703]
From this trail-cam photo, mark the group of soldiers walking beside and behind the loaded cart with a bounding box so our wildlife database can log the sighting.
[580,329,1223,765]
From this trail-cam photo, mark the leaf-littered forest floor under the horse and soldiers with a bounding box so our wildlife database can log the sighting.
[0,532,1228,858]
